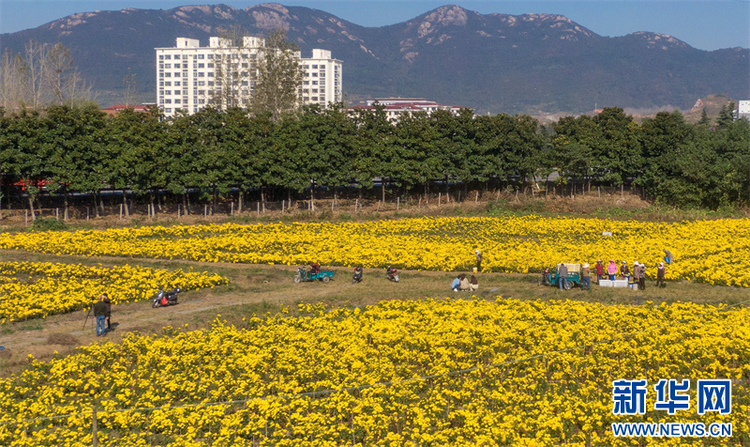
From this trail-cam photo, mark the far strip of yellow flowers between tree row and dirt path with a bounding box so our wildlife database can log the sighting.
[0,216,750,287]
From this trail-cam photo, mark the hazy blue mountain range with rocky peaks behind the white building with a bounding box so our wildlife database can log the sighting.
[0,4,750,115]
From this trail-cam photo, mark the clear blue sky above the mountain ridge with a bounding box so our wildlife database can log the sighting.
[0,0,750,50]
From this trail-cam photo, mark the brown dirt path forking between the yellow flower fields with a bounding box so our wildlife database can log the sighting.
[0,250,750,377]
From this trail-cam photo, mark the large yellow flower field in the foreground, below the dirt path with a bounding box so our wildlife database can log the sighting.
[0,298,750,446]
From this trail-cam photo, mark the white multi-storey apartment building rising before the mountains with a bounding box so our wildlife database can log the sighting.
[155,37,343,117]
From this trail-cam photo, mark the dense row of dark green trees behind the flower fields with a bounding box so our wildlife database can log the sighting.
[0,104,750,220]
